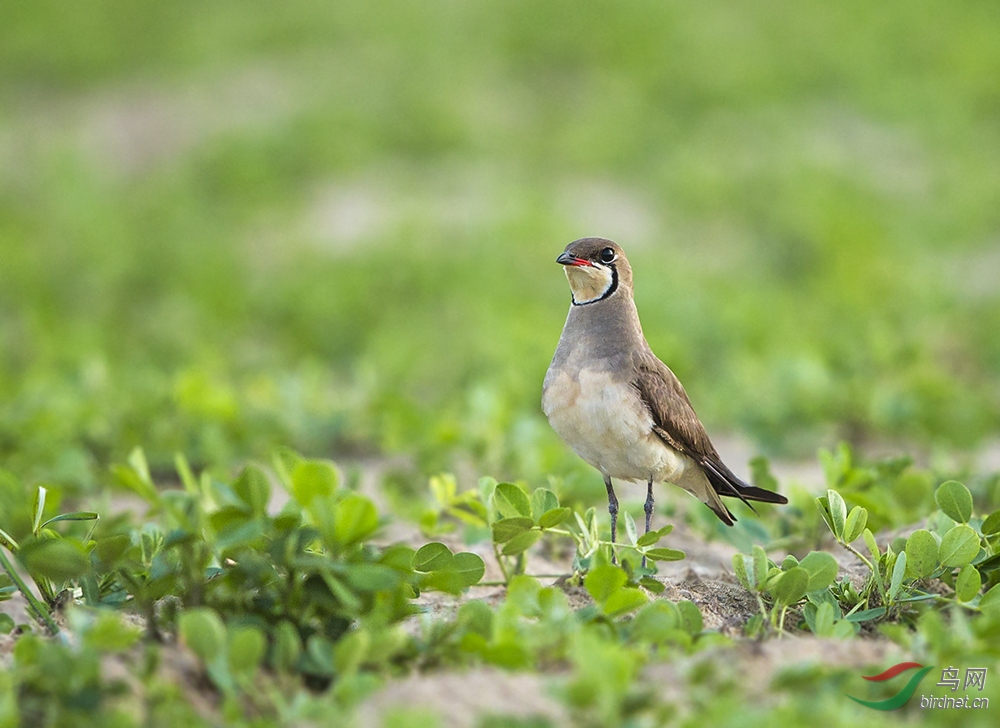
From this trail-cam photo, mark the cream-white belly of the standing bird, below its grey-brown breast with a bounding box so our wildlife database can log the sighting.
[542,370,700,487]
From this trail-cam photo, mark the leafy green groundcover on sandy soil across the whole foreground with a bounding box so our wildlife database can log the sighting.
[0,449,1000,726]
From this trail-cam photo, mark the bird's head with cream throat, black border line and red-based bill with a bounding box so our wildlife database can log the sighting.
[556,238,632,306]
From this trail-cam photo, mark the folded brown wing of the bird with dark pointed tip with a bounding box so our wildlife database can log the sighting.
[633,350,788,508]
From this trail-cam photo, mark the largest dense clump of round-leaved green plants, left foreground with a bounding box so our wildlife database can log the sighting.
[4,450,484,693]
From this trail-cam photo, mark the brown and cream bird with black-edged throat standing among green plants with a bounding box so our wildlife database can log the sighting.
[542,237,788,565]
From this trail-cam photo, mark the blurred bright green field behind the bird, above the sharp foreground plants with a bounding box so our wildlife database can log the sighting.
[0,0,1000,488]
